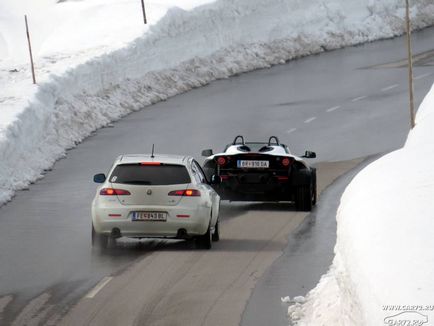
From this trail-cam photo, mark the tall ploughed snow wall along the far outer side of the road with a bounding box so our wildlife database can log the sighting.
[0,0,434,203]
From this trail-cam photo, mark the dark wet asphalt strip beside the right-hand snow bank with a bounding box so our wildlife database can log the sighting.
[241,156,380,326]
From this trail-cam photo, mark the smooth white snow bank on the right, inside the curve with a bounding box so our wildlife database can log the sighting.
[288,86,434,326]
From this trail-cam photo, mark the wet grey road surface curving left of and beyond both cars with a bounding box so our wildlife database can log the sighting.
[0,29,434,323]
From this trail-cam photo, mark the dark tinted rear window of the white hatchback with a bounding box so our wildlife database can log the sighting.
[109,163,191,186]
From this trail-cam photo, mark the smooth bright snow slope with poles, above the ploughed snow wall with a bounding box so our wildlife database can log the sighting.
[0,0,215,61]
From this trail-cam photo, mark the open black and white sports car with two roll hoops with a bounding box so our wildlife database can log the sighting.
[202,136,317,211]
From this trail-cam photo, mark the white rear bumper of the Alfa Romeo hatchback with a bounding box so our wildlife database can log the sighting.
[92,205,210,238]
